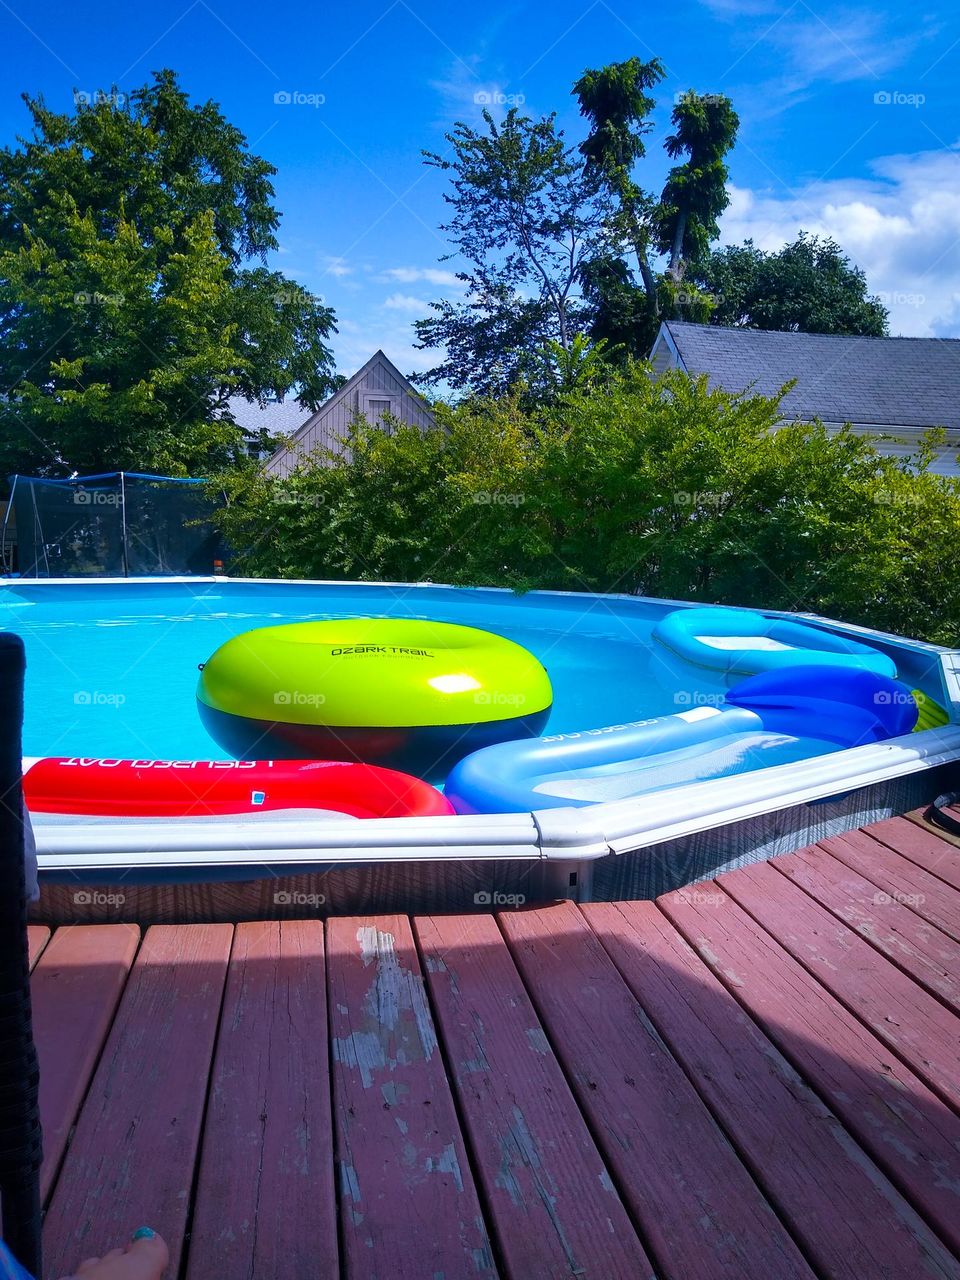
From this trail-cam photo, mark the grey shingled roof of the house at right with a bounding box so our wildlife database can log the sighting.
[654,320,960,431]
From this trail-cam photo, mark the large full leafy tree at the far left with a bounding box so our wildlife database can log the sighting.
[0,70,334,475]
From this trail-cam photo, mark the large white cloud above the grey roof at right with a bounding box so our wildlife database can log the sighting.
[721,145,960,338]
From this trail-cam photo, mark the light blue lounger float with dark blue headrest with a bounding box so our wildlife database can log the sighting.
[444,666,916,813]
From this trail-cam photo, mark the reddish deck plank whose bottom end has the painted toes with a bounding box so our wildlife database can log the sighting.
[44,924,233,1276]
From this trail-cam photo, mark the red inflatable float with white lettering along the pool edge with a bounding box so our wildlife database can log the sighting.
[23,756,453,818]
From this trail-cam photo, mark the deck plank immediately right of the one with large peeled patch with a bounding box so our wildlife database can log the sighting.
[413,915,653,1280]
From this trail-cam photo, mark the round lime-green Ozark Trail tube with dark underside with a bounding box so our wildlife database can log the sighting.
[197,618,553,777]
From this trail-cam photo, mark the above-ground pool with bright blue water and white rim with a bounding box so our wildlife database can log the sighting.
[0,579,960,890]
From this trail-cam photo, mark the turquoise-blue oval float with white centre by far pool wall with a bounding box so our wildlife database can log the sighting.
[653,608,897,678]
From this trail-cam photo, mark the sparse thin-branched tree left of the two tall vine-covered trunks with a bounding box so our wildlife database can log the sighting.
[415,108,605,394]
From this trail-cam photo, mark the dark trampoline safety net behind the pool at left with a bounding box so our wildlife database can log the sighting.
[3,471,223,577]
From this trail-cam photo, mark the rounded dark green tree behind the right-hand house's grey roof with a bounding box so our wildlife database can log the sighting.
[689,232,887,338]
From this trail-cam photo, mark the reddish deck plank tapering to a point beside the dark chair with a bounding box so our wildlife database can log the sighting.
[31,924,140,1201]
